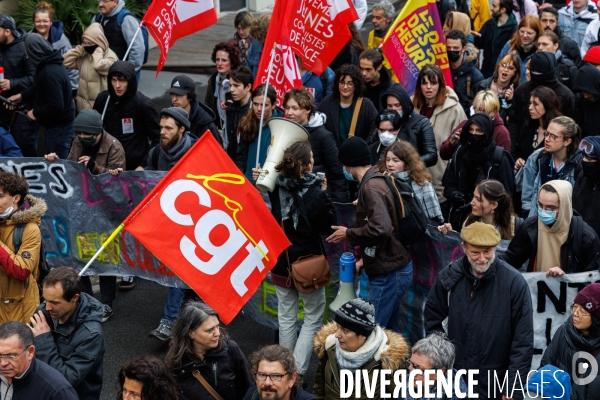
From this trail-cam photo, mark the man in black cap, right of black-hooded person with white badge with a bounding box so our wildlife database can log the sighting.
[167,75,223,144]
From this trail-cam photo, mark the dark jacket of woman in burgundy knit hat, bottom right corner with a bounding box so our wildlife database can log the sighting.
[540,317,600,400]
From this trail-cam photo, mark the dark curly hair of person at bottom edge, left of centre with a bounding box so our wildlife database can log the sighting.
[116,356,179,400]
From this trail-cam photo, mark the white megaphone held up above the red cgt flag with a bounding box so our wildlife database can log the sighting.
[256,118,308,193]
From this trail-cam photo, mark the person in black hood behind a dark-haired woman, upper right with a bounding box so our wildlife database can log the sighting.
[508,51,575,148]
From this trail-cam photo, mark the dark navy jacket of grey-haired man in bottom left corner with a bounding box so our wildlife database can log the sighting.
[12,357,79,400]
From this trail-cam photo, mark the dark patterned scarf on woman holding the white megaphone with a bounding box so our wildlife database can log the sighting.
[277,172,323,234]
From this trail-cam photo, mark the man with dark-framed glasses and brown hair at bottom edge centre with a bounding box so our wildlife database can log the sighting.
[244,344,315,400]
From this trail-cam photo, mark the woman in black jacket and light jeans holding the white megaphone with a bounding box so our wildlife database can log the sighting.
[253,141,337,382]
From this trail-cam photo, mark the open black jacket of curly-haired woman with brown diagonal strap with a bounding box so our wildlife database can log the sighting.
[317,94,378,149]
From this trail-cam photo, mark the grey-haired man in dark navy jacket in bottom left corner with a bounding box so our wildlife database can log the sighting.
[0,321,78,400]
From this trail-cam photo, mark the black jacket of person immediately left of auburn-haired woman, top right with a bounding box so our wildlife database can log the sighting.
[475,13,517,78]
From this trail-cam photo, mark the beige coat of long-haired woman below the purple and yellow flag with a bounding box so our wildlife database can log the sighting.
[415,87,467,203]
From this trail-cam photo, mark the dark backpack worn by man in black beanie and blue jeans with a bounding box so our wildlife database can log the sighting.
[358,173,427,247]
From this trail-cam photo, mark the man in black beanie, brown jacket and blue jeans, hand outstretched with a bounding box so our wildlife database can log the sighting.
[327,136,412,332]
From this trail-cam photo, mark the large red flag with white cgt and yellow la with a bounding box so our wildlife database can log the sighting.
[123,131,290,324]
